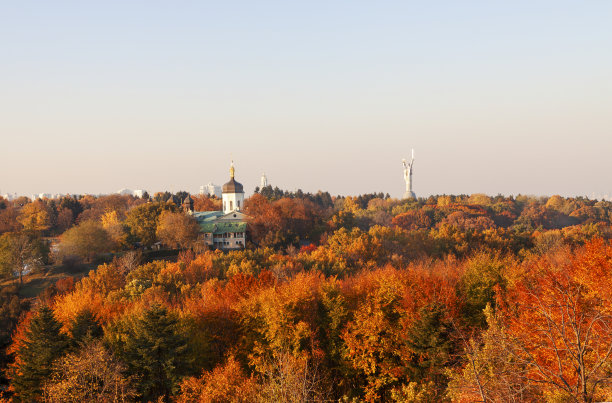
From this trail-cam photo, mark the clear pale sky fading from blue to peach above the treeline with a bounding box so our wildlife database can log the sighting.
[0,0,612,197]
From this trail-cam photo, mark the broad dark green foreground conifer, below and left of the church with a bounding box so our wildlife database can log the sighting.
[109,304,191,401]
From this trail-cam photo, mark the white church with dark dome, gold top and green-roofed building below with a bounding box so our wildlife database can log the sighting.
[183,161,248,250]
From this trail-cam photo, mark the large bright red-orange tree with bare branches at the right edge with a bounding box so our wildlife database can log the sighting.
[500,240,612,402]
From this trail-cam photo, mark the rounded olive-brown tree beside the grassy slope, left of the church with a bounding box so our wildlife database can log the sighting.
[60,220,114,261]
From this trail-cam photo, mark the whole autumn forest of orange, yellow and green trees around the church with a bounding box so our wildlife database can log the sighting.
[0,187,612,402]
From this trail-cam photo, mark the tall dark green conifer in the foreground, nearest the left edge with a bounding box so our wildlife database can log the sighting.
[11,306,68,401]
